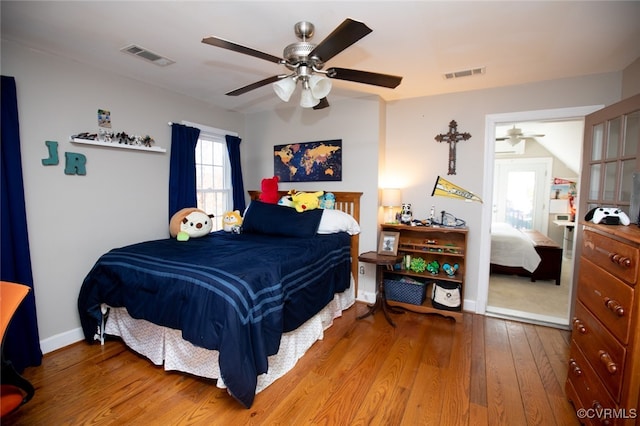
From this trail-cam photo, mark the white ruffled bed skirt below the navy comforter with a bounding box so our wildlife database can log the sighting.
[105,282,355,394]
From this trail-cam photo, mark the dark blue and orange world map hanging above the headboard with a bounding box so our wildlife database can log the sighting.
[273,139,342,182]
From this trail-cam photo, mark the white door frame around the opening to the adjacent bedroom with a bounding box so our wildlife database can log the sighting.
[476,105,602,328]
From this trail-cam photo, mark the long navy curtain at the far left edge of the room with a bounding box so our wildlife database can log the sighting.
[0,76,42,372]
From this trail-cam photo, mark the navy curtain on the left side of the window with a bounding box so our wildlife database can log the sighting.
[169,123,200,220]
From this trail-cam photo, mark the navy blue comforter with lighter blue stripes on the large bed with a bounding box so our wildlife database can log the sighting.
[78,231,351,407]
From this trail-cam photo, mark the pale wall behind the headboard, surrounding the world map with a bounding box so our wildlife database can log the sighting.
[241,96,384,300]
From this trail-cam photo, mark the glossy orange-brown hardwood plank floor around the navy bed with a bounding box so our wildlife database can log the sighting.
[2,304,578,426]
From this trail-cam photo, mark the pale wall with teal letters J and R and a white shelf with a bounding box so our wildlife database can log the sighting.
[2,41,244,352]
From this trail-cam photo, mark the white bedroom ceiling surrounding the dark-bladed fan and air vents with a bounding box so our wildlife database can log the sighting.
[0,0,640,112]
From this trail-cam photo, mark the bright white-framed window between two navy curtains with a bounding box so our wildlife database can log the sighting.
[188,122,233,231]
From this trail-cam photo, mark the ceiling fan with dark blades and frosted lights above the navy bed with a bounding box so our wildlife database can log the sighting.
[202,18,402,109]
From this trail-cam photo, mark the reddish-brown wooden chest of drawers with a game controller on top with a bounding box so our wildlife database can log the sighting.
[565,224,640,425]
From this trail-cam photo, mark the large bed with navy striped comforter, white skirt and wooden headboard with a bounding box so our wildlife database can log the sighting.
[78,191,361,408]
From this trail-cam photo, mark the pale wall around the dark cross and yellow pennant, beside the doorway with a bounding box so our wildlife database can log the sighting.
[383,73,621,310]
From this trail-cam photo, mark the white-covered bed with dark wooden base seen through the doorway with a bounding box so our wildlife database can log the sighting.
[490,223,562,285]
